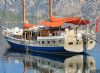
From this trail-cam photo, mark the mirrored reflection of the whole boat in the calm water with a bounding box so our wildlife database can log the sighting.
[0,53,96,73]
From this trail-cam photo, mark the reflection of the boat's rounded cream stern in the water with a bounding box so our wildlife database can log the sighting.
[64,55,96,73]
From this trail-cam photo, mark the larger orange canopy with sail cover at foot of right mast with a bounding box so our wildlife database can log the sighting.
[40,16,89,27]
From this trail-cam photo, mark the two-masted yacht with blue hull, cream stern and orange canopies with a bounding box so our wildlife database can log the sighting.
[3,0,95,53]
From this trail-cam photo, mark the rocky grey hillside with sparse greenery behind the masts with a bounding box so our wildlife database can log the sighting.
[0,0,100,23]
